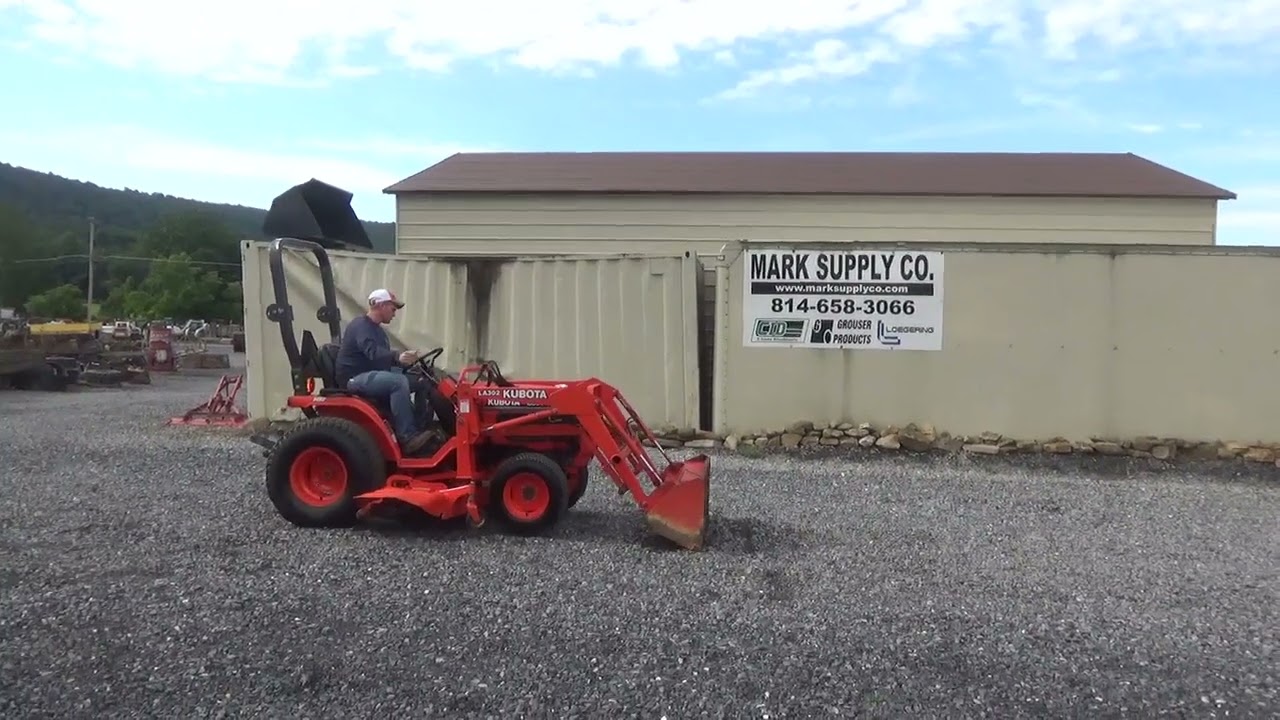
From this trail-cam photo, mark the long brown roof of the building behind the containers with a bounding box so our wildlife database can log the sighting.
[384,152,1235,200]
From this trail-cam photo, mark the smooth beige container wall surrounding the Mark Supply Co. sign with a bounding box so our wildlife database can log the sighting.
[714,243,1280,442]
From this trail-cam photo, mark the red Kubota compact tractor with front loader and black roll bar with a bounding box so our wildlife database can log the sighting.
[253,233,710,550]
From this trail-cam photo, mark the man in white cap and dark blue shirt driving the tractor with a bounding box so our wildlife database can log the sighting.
[337,288,445,455]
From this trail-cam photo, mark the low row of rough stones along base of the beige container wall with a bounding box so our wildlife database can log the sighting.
[646,421,1280,466]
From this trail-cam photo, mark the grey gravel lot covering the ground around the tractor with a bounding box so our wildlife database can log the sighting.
[0,356,1280,719]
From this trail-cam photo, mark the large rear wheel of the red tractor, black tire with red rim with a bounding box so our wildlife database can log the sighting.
[266,418,385,528]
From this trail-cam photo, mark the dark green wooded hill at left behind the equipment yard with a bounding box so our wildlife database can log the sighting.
[0,163,396,320]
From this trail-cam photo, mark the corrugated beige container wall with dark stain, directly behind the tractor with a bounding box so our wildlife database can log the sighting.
[243,242,699,428]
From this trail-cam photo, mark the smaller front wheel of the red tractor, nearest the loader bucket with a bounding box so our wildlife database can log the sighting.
[489,452,570,534]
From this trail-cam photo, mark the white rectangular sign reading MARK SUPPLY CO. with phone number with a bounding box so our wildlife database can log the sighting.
[742,250,942,351]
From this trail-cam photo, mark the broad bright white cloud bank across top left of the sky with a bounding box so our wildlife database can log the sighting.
[0,0,904,82]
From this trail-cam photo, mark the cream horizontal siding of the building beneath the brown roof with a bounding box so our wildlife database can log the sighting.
[397,193,1217,255]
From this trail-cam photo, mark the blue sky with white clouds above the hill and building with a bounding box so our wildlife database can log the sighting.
[0,0,1280,245]
